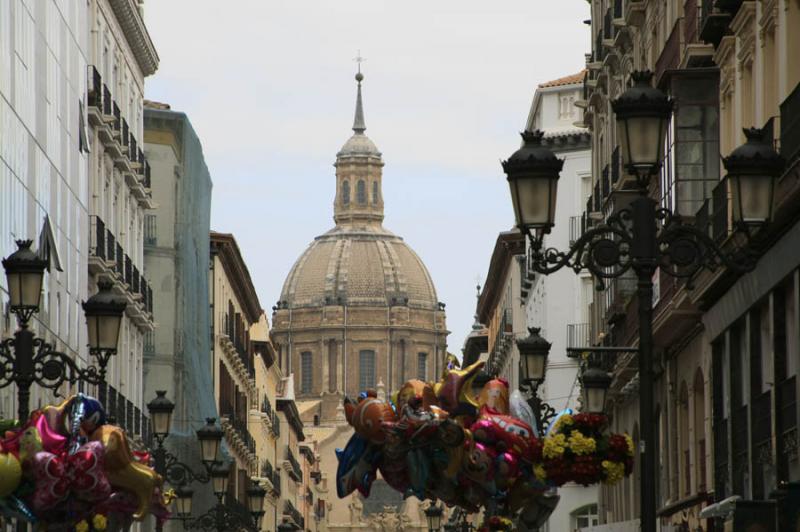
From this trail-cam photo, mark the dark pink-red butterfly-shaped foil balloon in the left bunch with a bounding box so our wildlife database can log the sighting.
[30,442,111,512]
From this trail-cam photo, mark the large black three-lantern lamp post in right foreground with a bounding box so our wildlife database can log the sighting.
[503,72,784,532]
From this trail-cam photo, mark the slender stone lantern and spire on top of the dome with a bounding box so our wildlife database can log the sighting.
[333,70,383,225]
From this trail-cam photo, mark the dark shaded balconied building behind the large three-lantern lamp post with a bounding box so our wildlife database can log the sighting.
[578,0,800,530]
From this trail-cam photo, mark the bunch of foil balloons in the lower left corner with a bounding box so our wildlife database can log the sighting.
[0,394,170,532]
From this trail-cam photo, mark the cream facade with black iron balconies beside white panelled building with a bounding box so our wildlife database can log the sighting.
[86,0,159,434]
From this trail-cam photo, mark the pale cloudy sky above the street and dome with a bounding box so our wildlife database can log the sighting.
[145,0,590,355]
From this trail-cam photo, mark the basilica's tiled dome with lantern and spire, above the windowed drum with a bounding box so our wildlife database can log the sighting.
[279,74,438,309]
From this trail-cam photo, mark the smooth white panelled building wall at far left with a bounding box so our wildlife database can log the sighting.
[0,2,94,418]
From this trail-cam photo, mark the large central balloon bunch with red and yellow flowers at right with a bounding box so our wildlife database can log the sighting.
[336,362,633,526]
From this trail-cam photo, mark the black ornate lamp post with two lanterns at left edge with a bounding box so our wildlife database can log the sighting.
[0,240,127,422]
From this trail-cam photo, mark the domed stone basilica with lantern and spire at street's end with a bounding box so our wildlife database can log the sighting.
[272,73,448,531]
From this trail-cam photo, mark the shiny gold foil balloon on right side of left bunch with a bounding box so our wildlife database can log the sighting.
[90,425,163,520]
